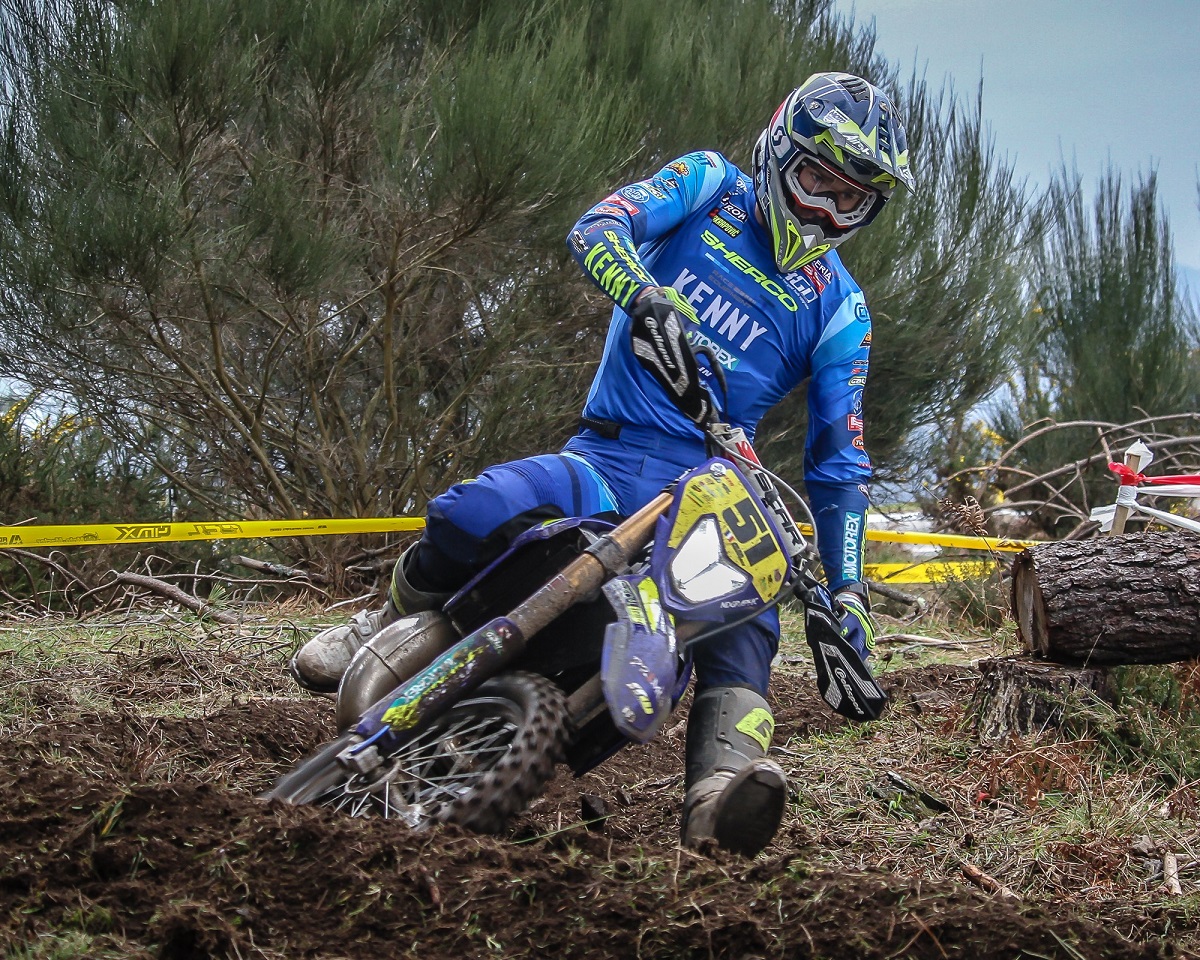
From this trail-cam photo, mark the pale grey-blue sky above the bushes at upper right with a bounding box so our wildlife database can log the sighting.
[835,0,1200,286]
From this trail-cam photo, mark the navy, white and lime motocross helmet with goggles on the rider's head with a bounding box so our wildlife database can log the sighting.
[754,73,913,274]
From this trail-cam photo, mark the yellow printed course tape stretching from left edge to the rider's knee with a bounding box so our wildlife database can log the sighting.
[0,517,425,550]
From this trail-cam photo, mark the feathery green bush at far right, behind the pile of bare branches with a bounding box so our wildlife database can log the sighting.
[989,168,1200,534]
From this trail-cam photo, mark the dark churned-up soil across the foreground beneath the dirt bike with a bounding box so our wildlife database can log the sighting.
[0,628,1195,960]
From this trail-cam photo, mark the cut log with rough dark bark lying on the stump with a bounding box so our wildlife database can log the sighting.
[1012,532,1200,666]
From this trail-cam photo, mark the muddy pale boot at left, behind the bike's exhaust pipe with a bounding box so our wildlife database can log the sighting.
[288,544,452,694]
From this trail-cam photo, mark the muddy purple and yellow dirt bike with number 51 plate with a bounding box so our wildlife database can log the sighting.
[266,391,886,833]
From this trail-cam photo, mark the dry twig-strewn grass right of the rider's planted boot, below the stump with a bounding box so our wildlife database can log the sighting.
[781,652,1200,931]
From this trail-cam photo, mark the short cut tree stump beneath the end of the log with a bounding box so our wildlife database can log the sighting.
[970,656,1109,744]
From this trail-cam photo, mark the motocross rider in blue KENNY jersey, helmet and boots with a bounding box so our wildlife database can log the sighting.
[293,73,912,856]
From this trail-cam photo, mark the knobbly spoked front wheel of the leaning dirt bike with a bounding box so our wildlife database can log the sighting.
[265,673,570,833]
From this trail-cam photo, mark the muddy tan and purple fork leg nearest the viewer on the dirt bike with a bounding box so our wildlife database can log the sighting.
[338,493,673,775]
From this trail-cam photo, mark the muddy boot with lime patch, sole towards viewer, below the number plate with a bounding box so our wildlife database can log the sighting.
[680,686,787,857]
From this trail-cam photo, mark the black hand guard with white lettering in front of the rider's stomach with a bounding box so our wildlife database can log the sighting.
[629,287,713,426]
